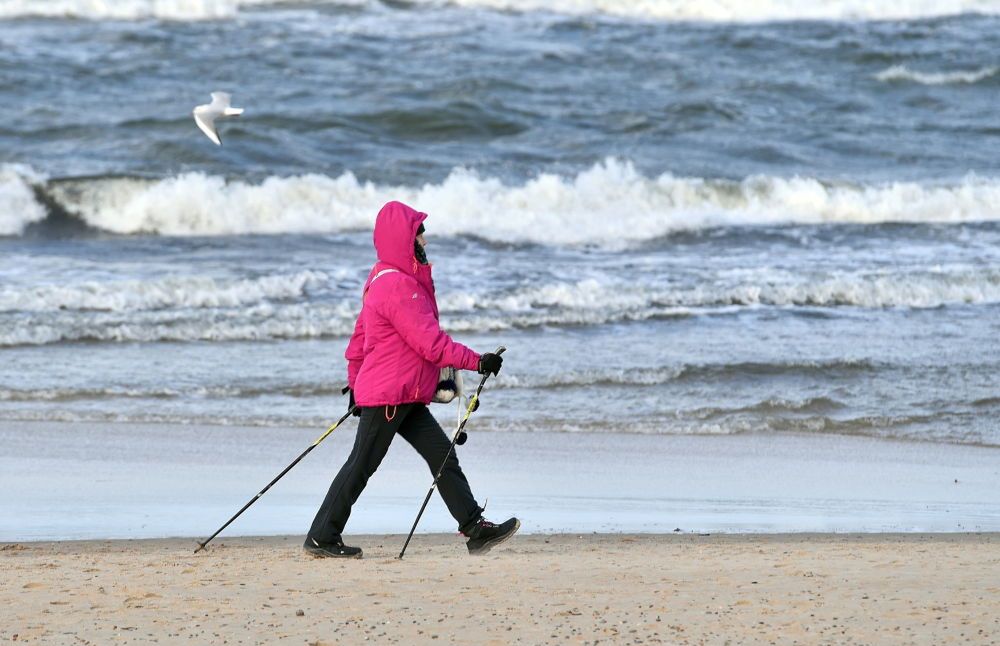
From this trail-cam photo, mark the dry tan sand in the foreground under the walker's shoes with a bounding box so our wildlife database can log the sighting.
[0,534,1000,644]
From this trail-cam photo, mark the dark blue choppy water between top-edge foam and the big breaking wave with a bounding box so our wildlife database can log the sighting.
[0,8,1000,185]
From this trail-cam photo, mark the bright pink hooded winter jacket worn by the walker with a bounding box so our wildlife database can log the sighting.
[344,202,479,406]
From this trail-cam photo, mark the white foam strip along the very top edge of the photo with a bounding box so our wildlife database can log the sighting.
[0,0,1000,22]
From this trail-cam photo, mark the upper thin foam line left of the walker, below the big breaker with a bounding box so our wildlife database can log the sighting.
[0,271,329,312]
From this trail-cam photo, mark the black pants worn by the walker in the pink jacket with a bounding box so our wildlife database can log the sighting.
[308,404,483,543]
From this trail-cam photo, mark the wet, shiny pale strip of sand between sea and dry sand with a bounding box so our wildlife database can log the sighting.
[0,423,1000,542]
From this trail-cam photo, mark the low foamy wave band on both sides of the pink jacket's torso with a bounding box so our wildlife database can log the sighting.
[0,267,1000,350]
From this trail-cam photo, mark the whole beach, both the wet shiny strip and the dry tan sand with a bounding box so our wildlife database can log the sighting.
[0,424,1000,644]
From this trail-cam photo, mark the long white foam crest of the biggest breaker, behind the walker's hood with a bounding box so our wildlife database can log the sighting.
[43,159,1000,247]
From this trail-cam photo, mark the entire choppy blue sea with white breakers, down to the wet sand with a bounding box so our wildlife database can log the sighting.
[0,0,1000,540]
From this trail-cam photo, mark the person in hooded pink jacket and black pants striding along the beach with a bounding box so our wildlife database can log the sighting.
[304,202,521,558]
